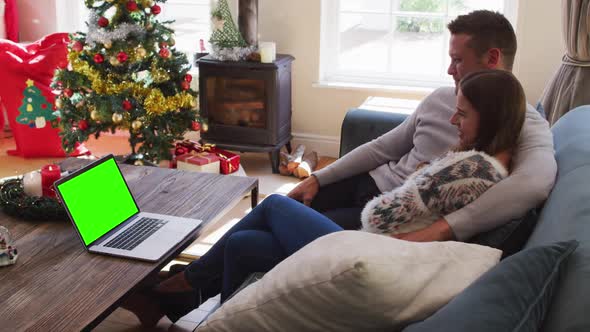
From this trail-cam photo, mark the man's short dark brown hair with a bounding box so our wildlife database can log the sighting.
[447,10,516,71]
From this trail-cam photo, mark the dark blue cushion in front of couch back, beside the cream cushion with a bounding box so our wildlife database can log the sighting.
[404,240,578,332]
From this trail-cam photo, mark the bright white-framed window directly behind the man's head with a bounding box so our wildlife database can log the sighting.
[320,0,517,87]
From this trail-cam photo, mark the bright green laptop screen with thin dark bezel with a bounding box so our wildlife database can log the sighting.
[57,156,139,245]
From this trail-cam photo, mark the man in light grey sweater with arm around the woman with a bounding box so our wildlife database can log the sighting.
[288,10,557,241]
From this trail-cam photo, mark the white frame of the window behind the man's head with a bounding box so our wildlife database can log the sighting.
[318,0,519,91]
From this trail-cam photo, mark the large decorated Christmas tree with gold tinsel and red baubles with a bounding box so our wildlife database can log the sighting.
[53,0,200,162]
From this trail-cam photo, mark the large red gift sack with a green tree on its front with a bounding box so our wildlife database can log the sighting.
[0,33,80,157]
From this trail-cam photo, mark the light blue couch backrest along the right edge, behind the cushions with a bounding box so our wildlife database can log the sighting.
[525,106,590,331]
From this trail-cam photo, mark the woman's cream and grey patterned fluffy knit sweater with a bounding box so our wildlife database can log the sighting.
[361,150,508,234]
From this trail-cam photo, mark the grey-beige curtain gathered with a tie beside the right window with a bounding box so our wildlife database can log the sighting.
[541,0,590,125]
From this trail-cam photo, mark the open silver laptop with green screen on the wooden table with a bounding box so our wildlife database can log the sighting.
[54,155,202,262]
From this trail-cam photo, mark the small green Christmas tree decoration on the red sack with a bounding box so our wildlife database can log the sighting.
[16,79,57,128]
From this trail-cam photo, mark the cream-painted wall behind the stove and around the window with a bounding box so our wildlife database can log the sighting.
[18,0,565,156]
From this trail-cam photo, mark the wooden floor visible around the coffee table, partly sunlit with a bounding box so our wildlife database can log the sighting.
[0,129,334,332]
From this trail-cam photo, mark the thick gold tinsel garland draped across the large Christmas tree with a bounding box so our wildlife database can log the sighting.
[68,52,195,115]
